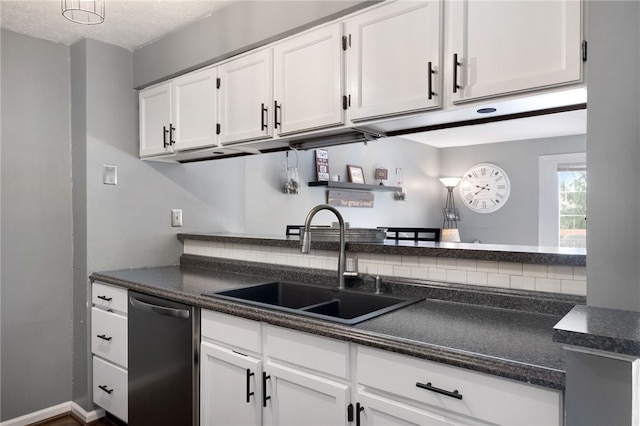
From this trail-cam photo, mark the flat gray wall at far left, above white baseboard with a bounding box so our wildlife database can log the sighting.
[0,30,72,420]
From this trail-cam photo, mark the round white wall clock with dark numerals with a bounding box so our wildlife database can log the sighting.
[459,163,511,213]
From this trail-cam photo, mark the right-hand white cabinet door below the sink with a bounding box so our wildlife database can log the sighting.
[265,362,350,426]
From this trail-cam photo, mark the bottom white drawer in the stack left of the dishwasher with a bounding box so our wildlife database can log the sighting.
[93,356,128,422]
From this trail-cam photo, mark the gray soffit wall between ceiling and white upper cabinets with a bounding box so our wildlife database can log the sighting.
[133,0,379,87]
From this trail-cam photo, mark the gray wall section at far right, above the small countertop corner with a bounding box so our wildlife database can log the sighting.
[587,1,640,311]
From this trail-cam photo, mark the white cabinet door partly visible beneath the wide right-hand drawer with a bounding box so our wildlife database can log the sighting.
[356,392,480,426]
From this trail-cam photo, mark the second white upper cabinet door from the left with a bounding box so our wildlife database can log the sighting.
[171,68,218,151]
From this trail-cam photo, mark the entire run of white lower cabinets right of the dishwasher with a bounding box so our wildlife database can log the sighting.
[200,310,564,426]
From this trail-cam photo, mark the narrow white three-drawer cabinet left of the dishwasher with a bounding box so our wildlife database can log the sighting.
[91,283,129,422]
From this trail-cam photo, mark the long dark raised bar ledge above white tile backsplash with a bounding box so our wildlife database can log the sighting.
[178,233,587,266]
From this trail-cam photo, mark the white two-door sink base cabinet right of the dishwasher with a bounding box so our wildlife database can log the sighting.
[200,310,351,426]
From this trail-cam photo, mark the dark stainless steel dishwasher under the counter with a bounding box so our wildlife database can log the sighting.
[128,290,200,426]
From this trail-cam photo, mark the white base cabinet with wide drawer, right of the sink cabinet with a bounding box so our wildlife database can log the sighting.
[356,346,564,426]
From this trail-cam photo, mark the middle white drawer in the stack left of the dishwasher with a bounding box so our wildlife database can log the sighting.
[91,307,127,368]
